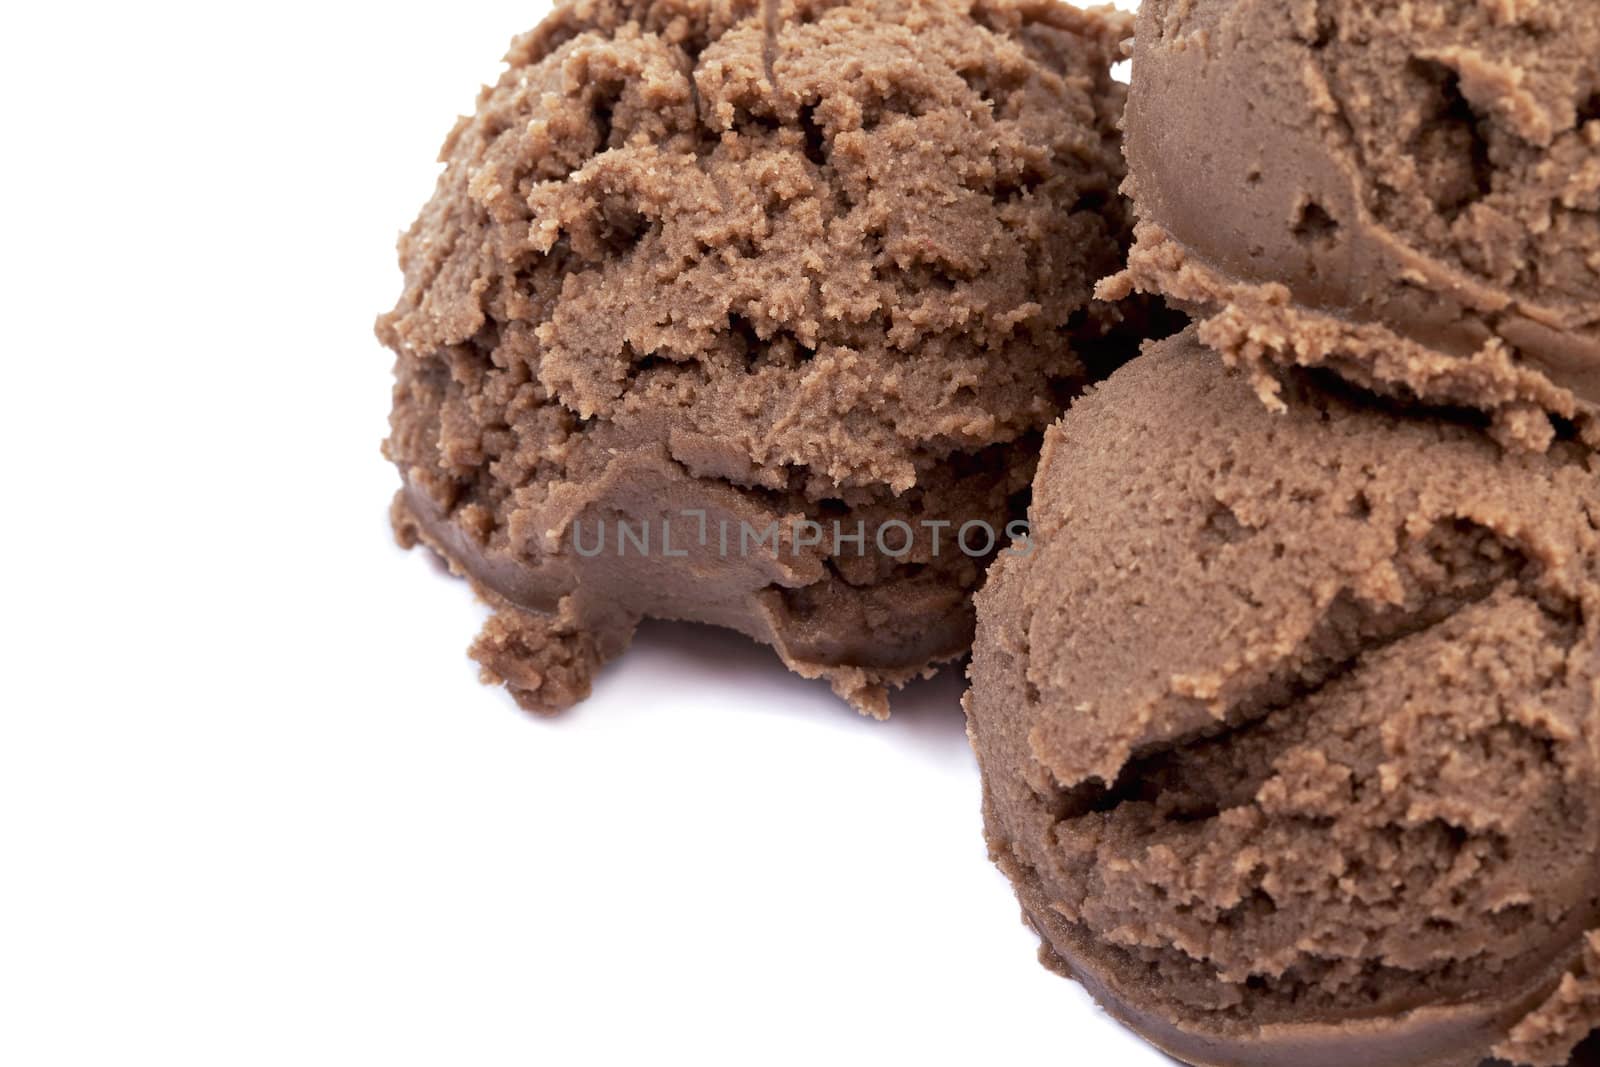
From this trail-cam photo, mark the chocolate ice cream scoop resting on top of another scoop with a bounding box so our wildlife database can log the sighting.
[1102,0,1600,450]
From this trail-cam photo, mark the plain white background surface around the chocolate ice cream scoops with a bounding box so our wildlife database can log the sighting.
[0,0,1166,1067]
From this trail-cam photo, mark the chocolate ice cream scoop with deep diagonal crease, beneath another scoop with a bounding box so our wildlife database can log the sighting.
[968,331,1600,1067]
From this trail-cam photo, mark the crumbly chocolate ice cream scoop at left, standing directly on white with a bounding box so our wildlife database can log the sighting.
[378,0,1133,715]
